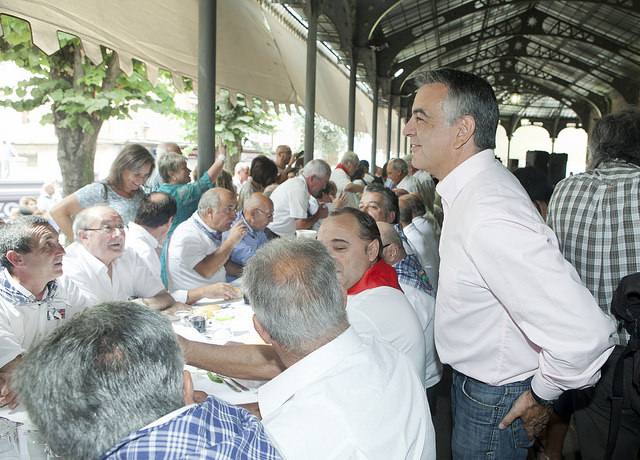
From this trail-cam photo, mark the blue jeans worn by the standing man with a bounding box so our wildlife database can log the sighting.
[451,371,533,460]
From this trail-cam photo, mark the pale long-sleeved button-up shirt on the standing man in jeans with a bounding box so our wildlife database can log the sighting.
[436,150,615,399]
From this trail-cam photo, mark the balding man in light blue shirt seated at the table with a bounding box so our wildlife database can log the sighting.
[222,193,273,282]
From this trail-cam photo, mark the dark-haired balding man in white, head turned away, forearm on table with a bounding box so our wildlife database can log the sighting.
[125,192,238,305]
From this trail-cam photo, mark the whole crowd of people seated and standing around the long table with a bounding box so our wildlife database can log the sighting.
[0,69,640,460]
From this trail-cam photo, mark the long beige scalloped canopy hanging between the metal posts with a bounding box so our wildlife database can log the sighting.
[0,0,396,150]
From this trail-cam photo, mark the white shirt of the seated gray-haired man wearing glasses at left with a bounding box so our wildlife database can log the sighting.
[63,241,164,304]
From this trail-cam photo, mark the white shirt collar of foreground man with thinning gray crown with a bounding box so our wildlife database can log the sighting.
[258,327,362,420]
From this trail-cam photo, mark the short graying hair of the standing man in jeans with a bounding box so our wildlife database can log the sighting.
[416,68,498,150]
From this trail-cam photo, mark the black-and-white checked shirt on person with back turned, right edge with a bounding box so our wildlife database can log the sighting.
[547,161,640,343]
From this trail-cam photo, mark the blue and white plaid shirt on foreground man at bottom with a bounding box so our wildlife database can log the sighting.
[102,396,281,460]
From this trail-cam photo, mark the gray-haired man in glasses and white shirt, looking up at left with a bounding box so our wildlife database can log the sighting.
[64,206,174,310]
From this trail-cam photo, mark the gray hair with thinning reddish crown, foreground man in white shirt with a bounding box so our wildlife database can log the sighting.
[242,239,348,355]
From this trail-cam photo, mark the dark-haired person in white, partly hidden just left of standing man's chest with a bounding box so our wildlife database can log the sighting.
[398,193,440,292]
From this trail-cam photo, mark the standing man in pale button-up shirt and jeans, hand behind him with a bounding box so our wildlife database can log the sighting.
[404,69,614,459]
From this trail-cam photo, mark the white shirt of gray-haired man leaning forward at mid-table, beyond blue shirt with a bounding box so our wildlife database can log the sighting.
[268,175,310,236]
